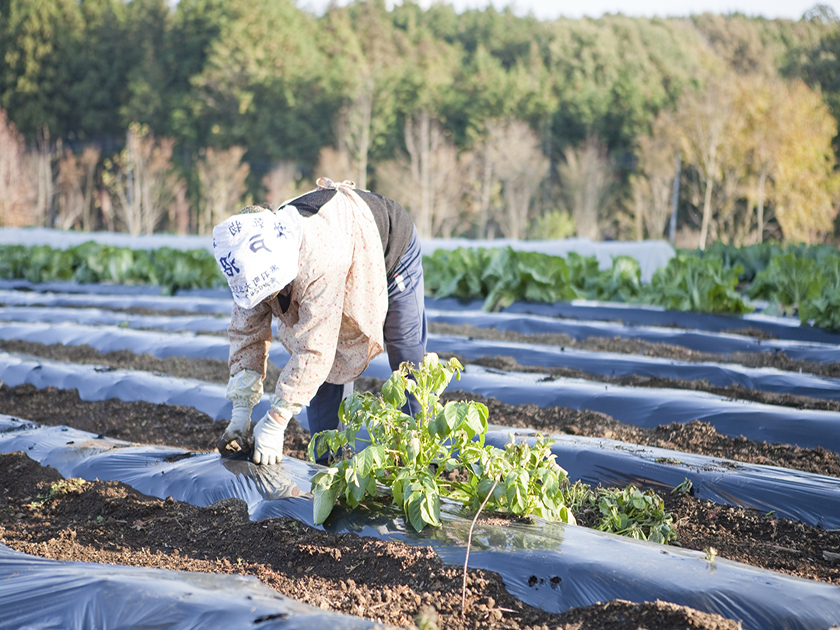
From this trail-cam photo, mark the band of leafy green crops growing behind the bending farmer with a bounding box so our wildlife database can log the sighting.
[0,241,840,330]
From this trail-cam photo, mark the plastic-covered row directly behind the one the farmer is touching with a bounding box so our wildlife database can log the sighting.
[0,354,840,529]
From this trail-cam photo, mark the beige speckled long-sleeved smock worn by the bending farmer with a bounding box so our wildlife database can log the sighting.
[228,180,388,408]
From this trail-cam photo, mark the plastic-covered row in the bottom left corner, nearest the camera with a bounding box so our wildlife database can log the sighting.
[0,544,374,630]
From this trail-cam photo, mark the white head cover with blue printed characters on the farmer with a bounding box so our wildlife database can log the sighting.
[213,206,301,308]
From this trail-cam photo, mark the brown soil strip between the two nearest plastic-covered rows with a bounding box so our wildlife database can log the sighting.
[0,453,741,630]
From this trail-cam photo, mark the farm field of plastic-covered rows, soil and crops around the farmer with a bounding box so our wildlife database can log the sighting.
[0,239,840,630]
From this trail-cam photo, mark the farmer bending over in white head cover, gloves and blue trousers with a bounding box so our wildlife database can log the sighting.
[213,178,426,464]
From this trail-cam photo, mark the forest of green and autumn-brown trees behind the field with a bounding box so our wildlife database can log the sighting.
[0,0,840,242]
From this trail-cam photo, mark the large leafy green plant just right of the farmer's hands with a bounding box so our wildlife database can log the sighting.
[309,353,574,531]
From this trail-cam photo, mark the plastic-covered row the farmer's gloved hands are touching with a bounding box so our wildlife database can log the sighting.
[0,417,840,629]
